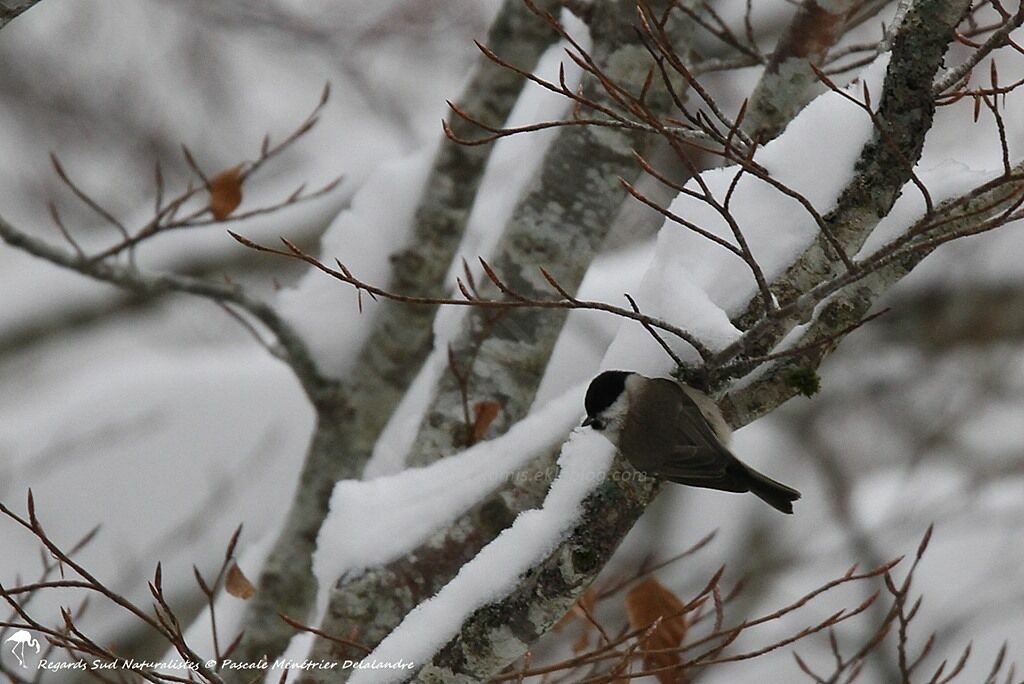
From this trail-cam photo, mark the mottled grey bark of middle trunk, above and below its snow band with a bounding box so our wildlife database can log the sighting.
[288,0,704,667]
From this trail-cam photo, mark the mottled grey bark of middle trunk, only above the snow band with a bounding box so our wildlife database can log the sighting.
[399,0,688,465]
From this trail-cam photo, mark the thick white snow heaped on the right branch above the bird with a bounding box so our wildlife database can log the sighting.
[602,56,888,375]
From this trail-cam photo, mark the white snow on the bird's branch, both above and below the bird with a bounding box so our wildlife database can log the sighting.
[336,52,905,681]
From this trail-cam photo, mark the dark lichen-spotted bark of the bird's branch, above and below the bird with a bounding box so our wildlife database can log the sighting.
[382,1,1014,678]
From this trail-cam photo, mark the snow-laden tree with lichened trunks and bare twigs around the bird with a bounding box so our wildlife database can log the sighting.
[0,0,1024,681]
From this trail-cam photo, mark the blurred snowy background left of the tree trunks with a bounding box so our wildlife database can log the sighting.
[0,0,491,653]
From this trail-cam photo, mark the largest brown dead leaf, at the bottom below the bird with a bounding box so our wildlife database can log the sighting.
[626,578,686,684]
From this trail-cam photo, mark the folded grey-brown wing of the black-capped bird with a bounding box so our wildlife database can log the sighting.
[618,378,748,491]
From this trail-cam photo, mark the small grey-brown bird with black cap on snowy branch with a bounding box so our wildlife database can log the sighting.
[583,371,800,513]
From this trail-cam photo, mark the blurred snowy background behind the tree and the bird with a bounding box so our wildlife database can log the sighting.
[0,0,1024,682]
